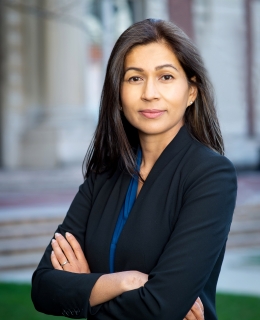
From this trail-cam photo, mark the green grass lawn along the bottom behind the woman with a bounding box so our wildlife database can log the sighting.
[0,283,260,320]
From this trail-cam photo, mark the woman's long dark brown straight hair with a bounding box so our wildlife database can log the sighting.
[83,19,224,179]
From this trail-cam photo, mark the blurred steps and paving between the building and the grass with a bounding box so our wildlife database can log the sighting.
[0,167,260,296]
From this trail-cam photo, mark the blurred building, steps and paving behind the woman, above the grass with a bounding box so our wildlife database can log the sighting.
[0,0,260,319]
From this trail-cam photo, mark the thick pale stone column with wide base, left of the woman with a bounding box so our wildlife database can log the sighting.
[23,0,95,167]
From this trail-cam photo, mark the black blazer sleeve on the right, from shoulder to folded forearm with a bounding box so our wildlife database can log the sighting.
[89,156,237,320]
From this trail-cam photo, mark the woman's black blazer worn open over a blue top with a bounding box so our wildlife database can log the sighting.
[32,126,237,320]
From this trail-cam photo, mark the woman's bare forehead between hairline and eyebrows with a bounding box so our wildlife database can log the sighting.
[124,42,181,68]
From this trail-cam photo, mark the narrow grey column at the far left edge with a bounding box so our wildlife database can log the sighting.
[1,7,24,168]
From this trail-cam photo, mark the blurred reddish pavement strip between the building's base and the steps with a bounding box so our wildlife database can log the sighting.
[0,167,260,207]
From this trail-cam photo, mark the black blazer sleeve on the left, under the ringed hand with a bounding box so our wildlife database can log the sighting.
[31,176,105,319]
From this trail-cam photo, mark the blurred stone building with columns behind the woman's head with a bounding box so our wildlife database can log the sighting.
[0,0,260,169]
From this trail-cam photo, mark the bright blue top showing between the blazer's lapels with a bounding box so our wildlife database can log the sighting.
[109,148,142,273]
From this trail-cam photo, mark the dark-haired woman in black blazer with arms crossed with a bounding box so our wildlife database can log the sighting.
[32,19,236,320]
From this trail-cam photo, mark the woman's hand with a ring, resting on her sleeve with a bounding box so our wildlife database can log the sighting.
[51,232,90,273]
